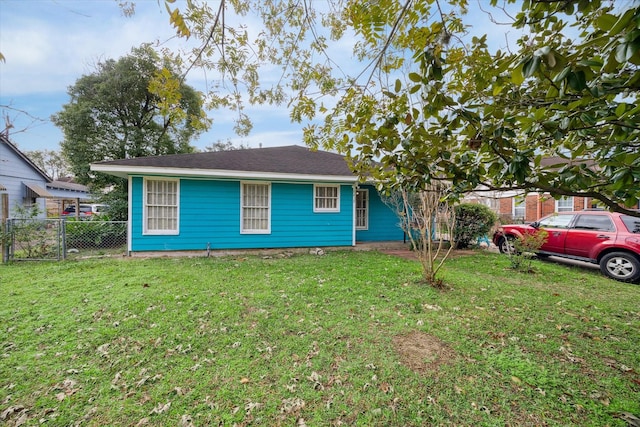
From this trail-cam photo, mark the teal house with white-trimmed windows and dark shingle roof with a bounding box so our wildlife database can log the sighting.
[91,146,404,252]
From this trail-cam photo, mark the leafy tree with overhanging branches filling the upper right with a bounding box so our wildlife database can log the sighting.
[165,0,640,215]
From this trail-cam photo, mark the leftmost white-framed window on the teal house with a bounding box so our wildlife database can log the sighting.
[143,178,180,234]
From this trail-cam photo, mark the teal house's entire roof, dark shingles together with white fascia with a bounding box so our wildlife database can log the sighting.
[91,145,356,181]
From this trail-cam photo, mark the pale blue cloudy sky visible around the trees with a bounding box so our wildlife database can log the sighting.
[0,0,506,151]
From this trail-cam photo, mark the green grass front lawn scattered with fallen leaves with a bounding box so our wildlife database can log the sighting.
[0,252,640,426]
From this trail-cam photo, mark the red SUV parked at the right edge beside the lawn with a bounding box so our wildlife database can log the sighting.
[493,210,640,283]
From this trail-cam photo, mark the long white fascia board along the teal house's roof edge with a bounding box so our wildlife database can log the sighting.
[91,164,358,182]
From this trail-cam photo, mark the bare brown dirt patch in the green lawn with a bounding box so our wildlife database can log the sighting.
[393,331,456,374]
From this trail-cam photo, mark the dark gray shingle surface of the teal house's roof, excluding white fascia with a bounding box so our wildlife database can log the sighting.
[95,145,354,177]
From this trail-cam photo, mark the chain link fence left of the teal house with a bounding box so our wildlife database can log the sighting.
[0,218,127,262]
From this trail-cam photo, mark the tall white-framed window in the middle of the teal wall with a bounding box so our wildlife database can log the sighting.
[240,182,271,234]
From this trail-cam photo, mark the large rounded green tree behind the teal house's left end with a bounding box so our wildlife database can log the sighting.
[52,46,209,188]
